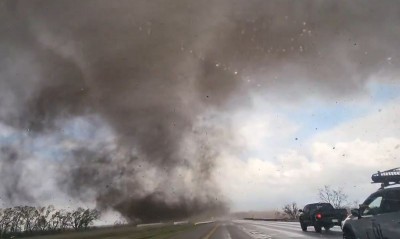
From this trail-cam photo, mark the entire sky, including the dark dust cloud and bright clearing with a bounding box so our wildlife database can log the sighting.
[0,0,400,222]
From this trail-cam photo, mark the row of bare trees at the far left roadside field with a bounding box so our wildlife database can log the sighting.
[0,206,100,238]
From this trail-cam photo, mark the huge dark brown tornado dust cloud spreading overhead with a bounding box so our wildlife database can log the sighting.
[0,0,400,221]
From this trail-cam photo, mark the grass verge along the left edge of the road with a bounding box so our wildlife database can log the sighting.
[31,224,194,239]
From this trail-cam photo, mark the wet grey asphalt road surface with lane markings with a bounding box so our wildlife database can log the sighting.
[173,220,342,239]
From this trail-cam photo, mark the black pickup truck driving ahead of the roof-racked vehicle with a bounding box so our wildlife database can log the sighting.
[299,203,347,232]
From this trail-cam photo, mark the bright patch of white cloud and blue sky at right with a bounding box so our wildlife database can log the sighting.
[219,82,400,211]
